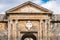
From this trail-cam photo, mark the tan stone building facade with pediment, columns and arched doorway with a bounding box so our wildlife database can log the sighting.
[0,1,60,40]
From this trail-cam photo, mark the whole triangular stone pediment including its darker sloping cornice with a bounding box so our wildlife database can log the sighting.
[6,1,52,13]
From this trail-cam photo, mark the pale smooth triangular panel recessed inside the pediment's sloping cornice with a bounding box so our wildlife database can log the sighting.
[12,5,44,13]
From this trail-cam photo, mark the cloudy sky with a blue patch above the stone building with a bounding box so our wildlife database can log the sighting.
[0,0,60,14]
